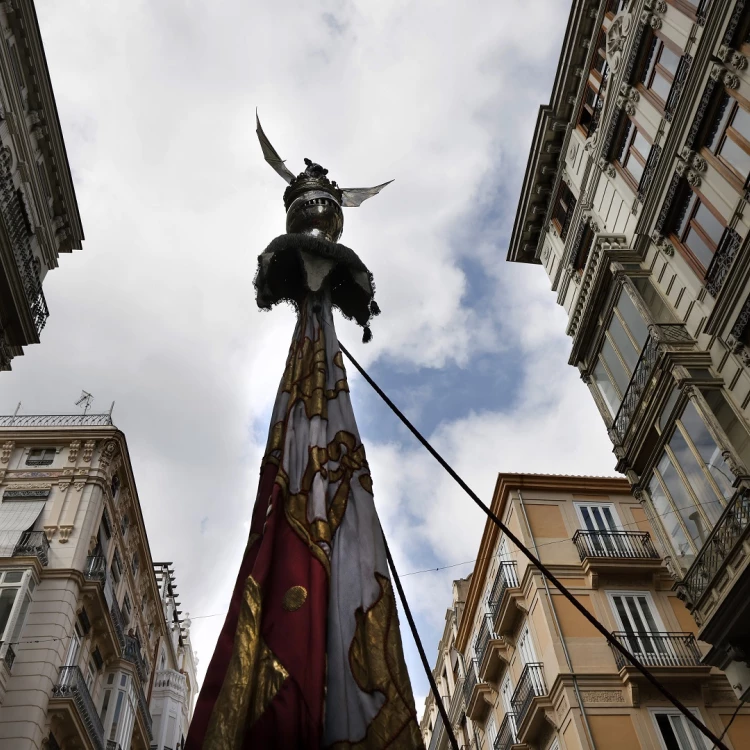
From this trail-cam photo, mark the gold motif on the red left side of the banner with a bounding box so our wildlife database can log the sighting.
[203,576,289,750]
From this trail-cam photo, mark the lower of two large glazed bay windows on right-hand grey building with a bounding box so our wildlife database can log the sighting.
[649,401,733,568]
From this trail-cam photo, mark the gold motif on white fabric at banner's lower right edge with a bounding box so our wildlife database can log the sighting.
[328,573,424,750]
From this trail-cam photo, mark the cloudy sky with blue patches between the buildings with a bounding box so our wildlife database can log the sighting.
[0,0,614,715]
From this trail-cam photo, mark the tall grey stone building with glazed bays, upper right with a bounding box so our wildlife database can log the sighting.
[508,0,750,697]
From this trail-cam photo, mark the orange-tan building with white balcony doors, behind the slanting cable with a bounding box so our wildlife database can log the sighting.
[423,474,750,750]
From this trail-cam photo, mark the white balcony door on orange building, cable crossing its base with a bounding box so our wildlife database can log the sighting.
[608,591,670,664]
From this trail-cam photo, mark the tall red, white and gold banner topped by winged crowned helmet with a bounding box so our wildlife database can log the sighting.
[185,121,424,750]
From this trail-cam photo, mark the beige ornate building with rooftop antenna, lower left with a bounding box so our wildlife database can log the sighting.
[0,414,198,750]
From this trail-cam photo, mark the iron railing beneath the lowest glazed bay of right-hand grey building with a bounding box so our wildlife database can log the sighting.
[681,490,750,607]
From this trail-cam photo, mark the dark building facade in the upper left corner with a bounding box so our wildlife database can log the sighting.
[0,0,83,370]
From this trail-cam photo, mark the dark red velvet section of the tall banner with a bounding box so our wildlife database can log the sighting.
[185,463,328,750]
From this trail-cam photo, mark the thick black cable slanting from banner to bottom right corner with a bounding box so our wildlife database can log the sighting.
[339,341,729,750]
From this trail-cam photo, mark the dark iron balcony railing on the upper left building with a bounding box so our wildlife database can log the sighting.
[0,151,49,336]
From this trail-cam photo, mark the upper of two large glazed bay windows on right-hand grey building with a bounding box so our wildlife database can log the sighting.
[591,289,648,418]
